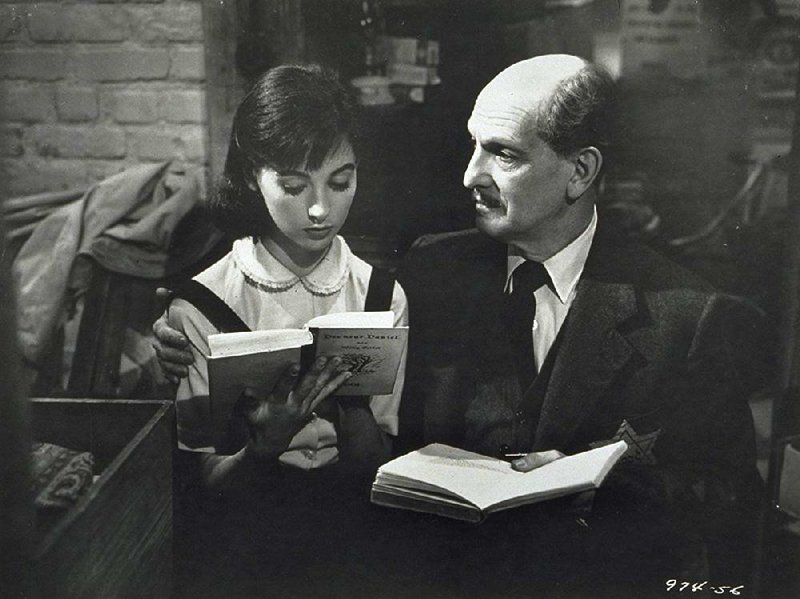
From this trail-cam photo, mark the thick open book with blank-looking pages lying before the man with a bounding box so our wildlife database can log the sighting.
[370,441,627,522]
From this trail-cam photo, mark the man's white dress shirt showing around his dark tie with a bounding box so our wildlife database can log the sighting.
[505,210,597,371]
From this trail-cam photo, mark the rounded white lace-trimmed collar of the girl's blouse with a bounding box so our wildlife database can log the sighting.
[232,236,351,295]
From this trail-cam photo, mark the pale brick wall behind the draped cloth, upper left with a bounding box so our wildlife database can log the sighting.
[0,0,206,199]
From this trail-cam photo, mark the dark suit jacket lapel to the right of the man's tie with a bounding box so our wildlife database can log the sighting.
[534,239,637,450]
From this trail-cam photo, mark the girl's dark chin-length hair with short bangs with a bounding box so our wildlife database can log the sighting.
[208,65,359,238]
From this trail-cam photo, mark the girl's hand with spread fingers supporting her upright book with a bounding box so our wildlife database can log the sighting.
[238,357,352,459]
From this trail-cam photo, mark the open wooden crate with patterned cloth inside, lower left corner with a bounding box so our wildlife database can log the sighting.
[31,399,174,599]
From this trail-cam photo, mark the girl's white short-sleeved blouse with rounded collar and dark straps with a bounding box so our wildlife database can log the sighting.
[168,237,408,469]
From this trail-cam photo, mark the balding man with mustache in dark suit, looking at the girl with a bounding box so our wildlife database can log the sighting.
[155,55,758,590]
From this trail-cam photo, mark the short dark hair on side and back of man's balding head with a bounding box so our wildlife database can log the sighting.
[535,63,616,165]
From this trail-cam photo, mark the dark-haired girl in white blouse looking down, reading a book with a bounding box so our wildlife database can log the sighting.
[168,66,407,487]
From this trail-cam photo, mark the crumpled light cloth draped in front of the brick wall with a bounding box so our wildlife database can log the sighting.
[12,162,221,366]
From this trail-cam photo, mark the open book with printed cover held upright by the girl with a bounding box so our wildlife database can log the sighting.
[208,310,408,448]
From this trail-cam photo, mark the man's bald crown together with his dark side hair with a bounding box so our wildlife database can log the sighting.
[475,54,614,161]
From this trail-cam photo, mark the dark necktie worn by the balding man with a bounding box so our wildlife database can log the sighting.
[506,261,550,393]
